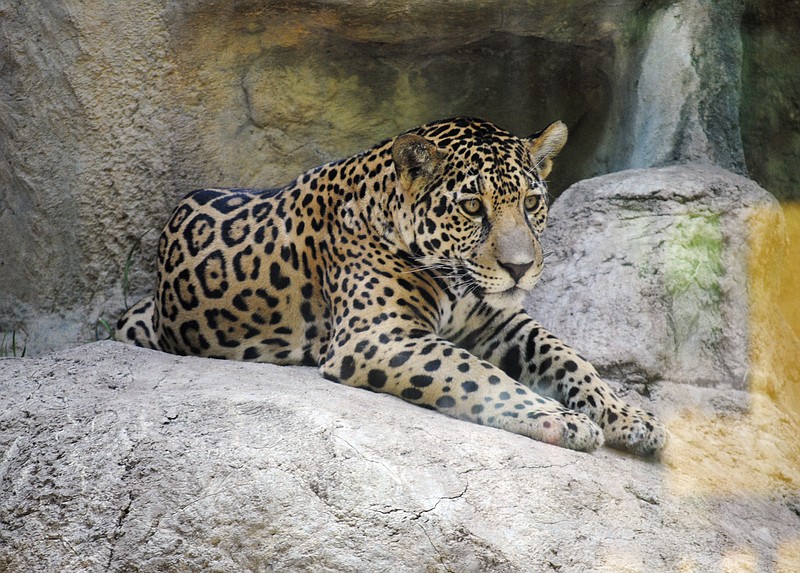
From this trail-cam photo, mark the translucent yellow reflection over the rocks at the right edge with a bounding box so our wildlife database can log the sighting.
[663,200,800,572]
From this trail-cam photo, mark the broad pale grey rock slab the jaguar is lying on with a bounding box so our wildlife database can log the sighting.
[0,342,800,573]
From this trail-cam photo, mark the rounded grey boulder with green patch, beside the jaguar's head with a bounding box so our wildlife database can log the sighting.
[527,165,800,398]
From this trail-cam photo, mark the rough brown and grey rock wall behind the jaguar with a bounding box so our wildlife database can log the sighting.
[0,0,795,354]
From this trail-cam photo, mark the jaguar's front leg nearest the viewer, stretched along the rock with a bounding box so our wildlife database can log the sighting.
[321,328,603,451]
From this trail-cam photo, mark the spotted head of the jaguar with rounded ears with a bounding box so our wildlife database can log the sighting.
[392,118,567,305]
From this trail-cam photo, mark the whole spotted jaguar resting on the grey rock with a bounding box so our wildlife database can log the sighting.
[117,118,665,455]
